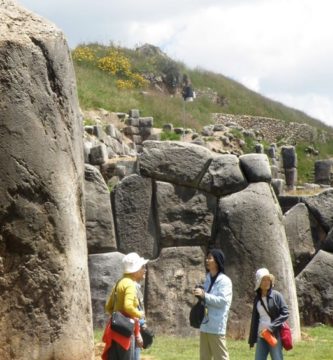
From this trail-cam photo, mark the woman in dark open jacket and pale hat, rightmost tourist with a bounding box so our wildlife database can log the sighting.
[249,268,289,360]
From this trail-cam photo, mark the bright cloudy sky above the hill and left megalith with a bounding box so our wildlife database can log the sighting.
[18,0,333,126]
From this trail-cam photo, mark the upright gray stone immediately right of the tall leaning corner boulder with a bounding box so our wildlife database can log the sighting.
[284,204,316,275]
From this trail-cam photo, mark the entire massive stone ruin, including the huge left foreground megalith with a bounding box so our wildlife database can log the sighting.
[0,0,333,360]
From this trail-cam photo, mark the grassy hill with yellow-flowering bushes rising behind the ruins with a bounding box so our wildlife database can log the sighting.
[72,44,333,183]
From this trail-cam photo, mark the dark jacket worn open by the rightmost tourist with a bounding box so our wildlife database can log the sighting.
[249,289,289,347]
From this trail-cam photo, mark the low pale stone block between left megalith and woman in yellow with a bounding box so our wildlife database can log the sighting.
[88,252,124,329]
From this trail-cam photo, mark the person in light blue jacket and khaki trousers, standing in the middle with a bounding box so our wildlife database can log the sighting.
[193,249,232,360]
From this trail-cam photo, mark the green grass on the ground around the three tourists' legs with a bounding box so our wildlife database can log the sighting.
[94,326,333,360]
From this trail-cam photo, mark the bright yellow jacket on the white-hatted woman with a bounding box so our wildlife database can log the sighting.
[105,275,143,319]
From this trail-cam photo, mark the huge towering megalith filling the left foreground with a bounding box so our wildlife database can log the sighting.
[0,0,94,360]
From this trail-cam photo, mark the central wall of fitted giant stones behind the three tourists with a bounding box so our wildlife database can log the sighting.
[86,141,300,339]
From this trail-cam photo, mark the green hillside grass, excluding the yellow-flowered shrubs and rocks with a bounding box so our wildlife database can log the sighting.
[74,44,333,185]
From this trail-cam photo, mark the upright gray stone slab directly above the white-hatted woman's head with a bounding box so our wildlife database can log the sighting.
[112,174,158,259]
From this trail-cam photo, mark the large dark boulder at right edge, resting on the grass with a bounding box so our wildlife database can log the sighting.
[296,250,333,326]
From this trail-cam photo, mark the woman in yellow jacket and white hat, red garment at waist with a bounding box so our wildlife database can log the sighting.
[102,253,148,360]
